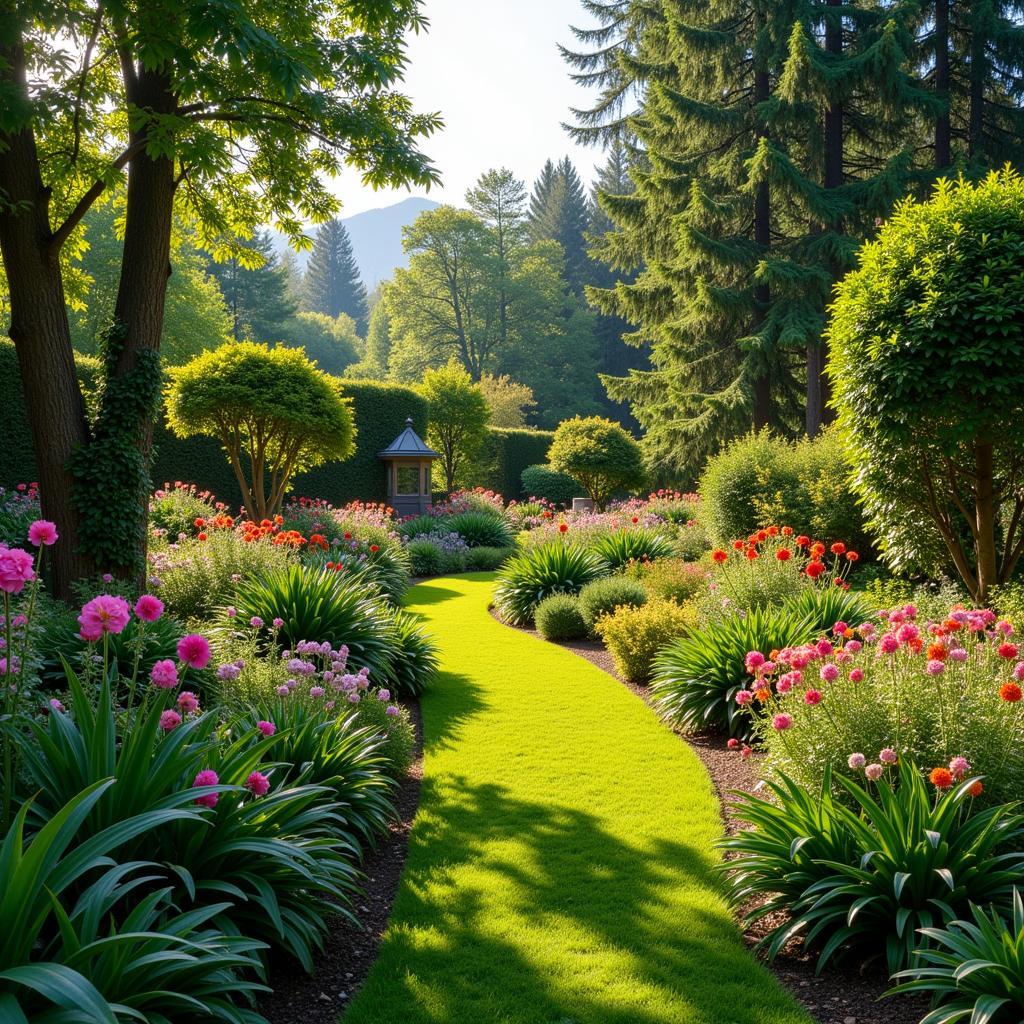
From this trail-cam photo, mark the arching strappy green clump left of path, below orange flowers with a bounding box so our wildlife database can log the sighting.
[234,564,396,679]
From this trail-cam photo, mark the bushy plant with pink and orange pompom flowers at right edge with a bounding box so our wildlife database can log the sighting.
[734,605,1024,802]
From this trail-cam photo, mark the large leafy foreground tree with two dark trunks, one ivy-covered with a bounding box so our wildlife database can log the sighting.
[0,0,438,595]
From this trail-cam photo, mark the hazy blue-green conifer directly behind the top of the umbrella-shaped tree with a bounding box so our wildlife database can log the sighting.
[209,230,296,341]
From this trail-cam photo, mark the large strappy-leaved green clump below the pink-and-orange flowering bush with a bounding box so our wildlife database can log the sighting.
[722,760,1024,974]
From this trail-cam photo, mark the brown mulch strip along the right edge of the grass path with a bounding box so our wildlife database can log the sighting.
[520,631,928,1024]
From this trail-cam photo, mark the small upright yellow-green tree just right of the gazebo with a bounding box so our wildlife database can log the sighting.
[419,359,490,492]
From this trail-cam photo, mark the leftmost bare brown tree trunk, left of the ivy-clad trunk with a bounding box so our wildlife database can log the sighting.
[0,46,92,598]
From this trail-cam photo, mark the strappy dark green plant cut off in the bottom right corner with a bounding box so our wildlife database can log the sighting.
[886,889,1024,1024]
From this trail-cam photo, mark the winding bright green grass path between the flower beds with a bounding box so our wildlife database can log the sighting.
[344,574,809,1024]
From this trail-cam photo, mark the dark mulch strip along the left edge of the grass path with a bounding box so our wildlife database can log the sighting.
[258,701,423,1024]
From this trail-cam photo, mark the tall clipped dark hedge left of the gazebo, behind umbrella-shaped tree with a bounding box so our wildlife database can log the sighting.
[0,340,429,507]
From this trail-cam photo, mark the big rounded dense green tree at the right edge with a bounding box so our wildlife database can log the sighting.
[827,170,1024,601]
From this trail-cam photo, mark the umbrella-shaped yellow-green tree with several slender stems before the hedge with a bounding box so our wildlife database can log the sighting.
[167,341,355,522]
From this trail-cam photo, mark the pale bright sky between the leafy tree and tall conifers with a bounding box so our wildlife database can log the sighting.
[334,0,602,217]
